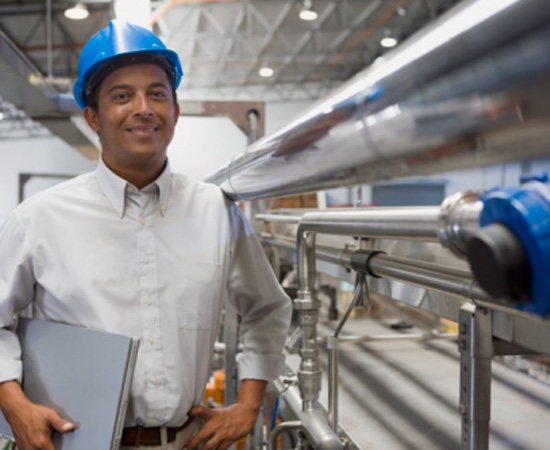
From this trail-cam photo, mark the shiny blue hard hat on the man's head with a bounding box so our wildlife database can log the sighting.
[73,20,183,109]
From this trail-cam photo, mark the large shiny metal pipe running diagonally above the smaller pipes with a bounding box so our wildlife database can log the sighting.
[208,0,550,200]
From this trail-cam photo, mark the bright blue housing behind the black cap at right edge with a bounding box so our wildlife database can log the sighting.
[480,173,550,317]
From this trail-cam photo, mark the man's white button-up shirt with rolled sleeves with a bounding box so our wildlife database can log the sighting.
[0,160,291,426]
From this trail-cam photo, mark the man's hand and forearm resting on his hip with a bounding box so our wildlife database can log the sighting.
[185,380,267,450]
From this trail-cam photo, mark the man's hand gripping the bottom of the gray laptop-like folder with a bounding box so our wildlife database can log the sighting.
[0,381,74,450]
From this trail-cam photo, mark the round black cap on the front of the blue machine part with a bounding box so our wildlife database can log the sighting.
[467,223,531,301]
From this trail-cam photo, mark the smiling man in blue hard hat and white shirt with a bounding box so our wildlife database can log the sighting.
[0,21,291,450]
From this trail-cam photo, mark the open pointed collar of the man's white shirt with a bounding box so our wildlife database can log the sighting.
[96,158,172,219]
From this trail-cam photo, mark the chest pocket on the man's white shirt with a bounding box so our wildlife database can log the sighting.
[177,262,224,330]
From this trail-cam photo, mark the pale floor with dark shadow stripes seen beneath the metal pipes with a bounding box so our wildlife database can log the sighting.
[319,319,550,450]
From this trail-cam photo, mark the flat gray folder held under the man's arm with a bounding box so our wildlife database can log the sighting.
[0,318,139,450]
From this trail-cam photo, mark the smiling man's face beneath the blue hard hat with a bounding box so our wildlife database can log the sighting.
[84,64,179,187]
